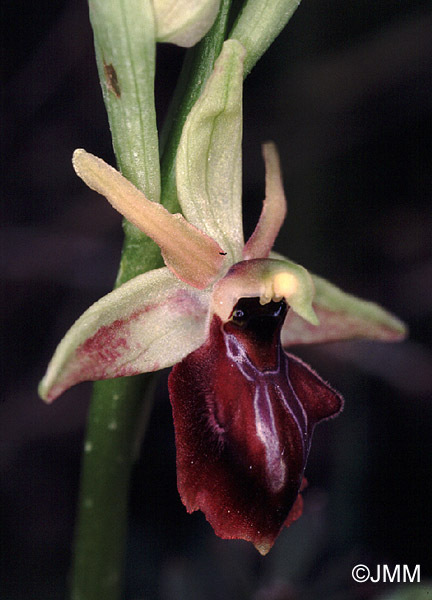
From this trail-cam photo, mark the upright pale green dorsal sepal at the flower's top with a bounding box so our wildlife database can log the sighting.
[176,40,245,262]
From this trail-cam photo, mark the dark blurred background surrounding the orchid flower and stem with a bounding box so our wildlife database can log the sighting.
[0,0,432,600]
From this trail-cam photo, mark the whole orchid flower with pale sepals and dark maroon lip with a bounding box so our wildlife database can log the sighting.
[40,40,404,554]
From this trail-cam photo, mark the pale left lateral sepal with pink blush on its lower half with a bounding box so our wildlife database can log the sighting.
[39,268,212,402]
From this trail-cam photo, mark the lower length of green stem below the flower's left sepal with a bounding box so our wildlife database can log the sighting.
[71,376,151,600]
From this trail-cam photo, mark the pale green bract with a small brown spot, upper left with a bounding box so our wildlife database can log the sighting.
[89,0,160,202]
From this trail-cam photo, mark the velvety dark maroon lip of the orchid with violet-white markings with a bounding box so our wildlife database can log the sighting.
[169,298,342,554]
